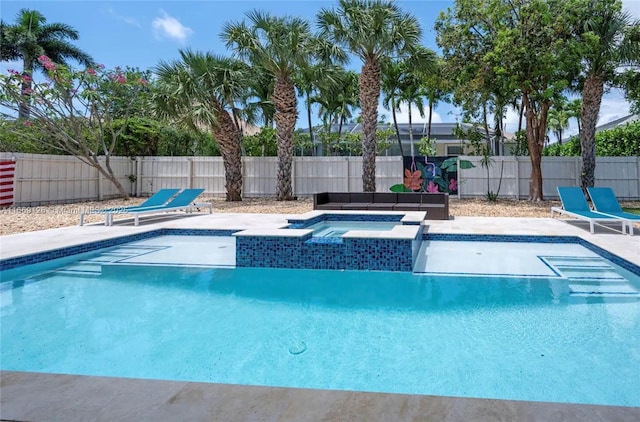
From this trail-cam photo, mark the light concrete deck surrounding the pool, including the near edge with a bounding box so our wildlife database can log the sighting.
[0,213,640,421]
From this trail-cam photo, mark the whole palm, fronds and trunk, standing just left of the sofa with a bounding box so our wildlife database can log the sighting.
[222,11,313,201]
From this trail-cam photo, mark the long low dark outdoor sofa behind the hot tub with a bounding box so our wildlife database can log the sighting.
[313,192,449,220]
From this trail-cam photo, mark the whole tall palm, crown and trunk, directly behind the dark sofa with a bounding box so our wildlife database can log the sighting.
[317,0,422,192]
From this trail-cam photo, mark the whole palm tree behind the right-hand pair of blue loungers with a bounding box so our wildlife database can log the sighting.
[580,0,640,190]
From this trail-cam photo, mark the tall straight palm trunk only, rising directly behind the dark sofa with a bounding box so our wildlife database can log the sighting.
[360,57,380,192]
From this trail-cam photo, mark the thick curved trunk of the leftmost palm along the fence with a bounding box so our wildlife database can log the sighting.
[211,109,242,202]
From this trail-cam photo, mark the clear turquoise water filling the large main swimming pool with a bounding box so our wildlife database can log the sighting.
[0,244,640,406]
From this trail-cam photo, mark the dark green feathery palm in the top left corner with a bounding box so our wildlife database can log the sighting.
[0,9,93,118]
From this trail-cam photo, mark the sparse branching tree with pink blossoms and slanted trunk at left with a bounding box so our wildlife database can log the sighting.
[0,56,148,199]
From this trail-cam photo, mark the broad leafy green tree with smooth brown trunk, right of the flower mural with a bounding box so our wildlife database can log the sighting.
[436,0,580,201]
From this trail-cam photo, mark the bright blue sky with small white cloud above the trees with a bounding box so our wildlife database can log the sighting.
[0,0,640,136]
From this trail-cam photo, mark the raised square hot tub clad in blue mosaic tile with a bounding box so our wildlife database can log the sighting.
[233,211,425,271]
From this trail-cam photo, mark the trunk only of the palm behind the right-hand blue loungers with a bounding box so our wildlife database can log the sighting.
[580,75,604,192]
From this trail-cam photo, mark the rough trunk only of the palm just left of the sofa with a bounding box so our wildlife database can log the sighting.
[273,76,298,201]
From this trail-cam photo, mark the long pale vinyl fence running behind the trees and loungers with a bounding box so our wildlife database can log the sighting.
[0,153,640,206]
